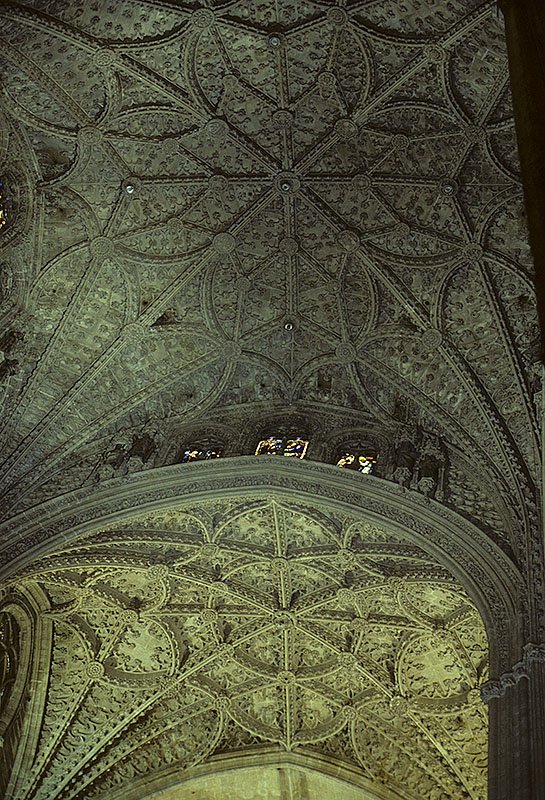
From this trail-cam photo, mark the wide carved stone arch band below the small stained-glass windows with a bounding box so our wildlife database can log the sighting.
[0,456,523,672]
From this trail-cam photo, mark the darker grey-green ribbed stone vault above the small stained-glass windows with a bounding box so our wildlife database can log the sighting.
[0,0,538,564]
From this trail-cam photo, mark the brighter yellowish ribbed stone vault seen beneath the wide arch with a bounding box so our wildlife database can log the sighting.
[3,498,488,800]
